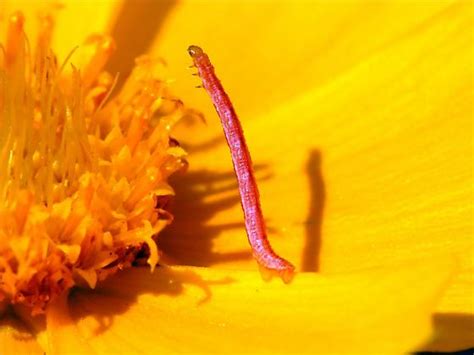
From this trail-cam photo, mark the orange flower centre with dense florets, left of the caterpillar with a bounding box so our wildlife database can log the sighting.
[0,13,186,315]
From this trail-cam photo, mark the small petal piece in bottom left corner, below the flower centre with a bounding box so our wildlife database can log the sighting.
[0,316,43,355]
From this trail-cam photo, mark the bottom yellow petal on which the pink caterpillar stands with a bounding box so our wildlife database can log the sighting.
[55,262,451,354]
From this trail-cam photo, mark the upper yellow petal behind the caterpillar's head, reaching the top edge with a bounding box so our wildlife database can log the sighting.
[151,0,460,143]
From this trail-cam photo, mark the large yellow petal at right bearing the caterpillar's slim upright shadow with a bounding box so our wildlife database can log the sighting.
[154,2,474,350]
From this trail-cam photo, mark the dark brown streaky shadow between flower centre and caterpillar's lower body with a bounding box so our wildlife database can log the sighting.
[157,161,270,266]
